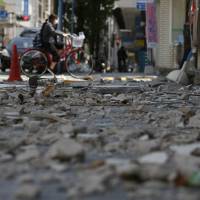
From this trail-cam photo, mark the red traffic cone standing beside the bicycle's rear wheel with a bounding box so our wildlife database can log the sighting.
[8,44,22,81]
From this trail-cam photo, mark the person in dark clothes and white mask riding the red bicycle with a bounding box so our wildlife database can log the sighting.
[41,14,67,71]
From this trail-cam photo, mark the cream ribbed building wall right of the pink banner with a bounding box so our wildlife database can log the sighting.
[155,0,186,68]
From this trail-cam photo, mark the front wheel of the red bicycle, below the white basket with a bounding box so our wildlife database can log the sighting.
[66,49,93,78]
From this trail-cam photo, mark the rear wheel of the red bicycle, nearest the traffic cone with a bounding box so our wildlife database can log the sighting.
[20,49,48,77]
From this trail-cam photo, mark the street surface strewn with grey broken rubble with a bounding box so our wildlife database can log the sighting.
[0,74,200,200]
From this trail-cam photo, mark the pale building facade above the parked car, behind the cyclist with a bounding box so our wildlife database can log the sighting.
[0,0,55,46]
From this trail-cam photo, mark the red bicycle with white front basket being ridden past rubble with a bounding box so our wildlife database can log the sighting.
[20,33,93,78]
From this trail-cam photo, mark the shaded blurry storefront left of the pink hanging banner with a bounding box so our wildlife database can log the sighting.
[111,0,149,72]
